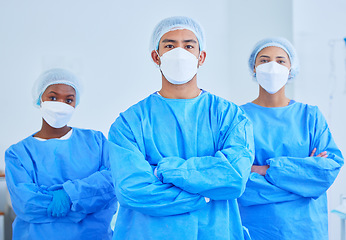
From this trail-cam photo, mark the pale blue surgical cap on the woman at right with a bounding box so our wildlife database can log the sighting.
[249,37,299,80]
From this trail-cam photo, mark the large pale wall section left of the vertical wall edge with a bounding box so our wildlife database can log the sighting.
[0,0,292,169]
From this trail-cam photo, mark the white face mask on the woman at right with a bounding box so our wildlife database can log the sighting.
[256,61,289,94]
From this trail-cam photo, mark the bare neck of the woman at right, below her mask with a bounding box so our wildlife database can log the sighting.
[253,86,290,107]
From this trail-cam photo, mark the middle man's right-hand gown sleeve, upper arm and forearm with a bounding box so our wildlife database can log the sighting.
[157,108,254,200]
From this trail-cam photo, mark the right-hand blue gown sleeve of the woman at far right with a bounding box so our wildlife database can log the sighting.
[265,108,344,198]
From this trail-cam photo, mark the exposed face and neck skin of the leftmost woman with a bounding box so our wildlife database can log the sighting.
[34,84,76,139]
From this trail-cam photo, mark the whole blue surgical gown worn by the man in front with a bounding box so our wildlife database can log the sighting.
[109,92,254,240]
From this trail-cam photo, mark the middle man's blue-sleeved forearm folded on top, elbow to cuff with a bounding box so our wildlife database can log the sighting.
[157,147,252,200]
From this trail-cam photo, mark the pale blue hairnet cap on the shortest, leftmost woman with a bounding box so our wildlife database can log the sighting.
[32,68,81,107]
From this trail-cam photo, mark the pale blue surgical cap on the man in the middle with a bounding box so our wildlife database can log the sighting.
[150,17,205,52]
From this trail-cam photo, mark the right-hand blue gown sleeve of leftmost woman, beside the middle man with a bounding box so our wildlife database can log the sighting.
[63,133,116,214]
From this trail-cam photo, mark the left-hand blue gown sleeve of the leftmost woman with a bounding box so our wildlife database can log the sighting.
[5,148,85,223]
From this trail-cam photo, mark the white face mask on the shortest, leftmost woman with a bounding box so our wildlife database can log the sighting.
[40,101,75,128]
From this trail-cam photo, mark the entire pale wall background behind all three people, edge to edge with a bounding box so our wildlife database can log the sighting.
[0,0,346,240]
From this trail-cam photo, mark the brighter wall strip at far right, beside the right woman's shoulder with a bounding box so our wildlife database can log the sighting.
[293,0,346,240]
